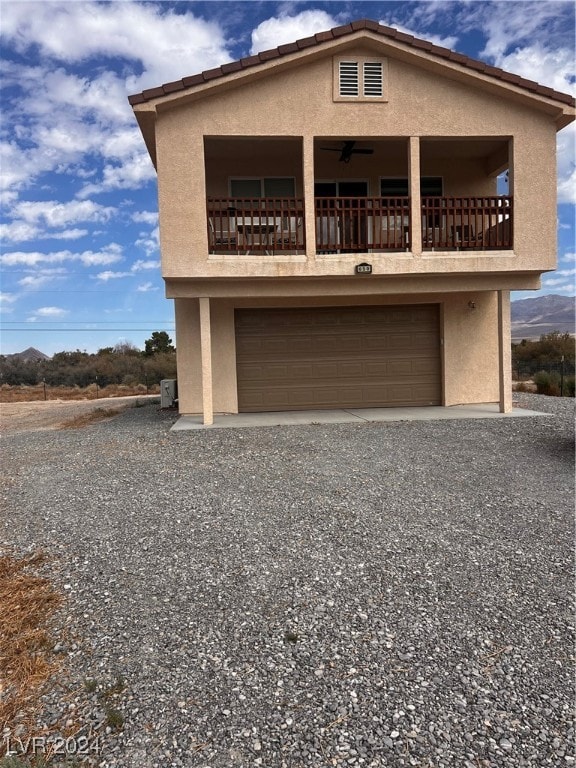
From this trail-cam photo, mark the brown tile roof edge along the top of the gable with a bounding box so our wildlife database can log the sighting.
[128,19,576,106]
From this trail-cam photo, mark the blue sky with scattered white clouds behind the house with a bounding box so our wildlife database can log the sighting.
[0,0,576,355]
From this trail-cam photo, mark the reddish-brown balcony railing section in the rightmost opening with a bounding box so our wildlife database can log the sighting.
[422,195,513,251]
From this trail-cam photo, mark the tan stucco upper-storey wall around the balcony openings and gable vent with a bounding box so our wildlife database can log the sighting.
[157,39,556,284]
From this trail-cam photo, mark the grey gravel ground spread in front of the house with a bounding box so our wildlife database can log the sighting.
[0,394,575,768]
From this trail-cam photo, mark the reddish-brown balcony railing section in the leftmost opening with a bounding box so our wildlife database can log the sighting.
[207,197,306,254]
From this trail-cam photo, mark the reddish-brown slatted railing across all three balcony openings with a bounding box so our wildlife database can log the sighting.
[207,196,513,255]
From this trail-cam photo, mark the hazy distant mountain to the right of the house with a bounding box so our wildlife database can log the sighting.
[511,294,576,341]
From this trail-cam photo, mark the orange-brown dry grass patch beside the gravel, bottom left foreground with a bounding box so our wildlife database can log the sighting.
[0,552,62,757]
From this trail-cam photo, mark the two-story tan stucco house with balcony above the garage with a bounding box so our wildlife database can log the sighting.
[130,21,574,424]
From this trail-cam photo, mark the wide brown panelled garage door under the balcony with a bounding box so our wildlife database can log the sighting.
[236,304,441,411]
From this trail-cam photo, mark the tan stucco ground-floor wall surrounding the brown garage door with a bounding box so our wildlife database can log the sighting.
[176,291,499,414]
